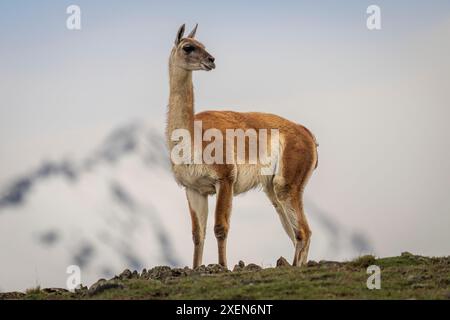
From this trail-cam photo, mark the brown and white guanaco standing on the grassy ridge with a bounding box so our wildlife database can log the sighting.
[166,24,318,268]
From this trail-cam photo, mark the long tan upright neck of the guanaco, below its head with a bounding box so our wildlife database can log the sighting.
[166,56,194,148]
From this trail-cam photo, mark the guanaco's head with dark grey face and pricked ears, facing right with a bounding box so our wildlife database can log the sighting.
[170,24,216,71]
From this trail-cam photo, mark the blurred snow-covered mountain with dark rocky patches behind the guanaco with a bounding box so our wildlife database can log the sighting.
[0,123,372,290]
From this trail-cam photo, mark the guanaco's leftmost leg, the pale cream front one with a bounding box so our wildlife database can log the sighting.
[186,189,208,268]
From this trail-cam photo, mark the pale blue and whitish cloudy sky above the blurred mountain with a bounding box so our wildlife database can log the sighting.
[0,0,450,276]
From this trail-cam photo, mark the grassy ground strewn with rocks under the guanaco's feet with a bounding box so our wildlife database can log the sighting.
[0,253,450,299]
